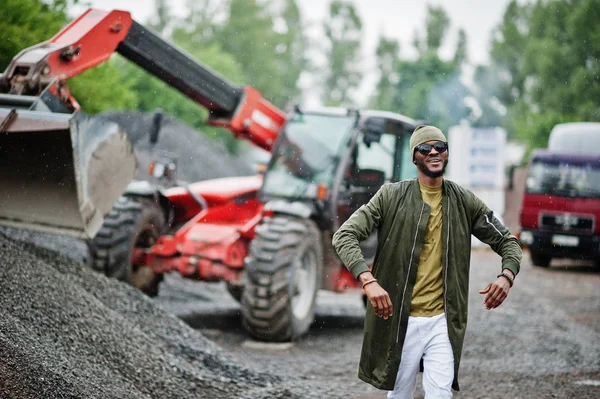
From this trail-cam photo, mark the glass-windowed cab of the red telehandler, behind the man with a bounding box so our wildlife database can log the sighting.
[261,109,416,230]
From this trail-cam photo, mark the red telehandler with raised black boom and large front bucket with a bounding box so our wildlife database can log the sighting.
[0,9,416,341]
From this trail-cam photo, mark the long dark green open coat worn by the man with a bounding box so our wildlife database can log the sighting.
[333,179,522,390]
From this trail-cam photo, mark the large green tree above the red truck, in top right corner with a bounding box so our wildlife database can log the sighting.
[481,0,600,148]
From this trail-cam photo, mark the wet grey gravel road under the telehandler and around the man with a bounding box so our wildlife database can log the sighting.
[155,250,600,399]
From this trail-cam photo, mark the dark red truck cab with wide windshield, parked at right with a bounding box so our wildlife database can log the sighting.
[520,150,600,267]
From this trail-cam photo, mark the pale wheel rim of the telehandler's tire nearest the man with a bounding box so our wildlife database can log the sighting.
[292,248,317,319]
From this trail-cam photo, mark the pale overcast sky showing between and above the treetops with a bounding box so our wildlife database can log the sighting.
[77,0,510,104]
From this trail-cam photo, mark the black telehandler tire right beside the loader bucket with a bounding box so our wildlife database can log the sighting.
[87,196,165,297]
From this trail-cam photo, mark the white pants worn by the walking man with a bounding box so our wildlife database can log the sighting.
[387,313,454,399]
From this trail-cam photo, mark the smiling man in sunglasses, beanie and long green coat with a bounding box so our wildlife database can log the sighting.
[333,126,522,399]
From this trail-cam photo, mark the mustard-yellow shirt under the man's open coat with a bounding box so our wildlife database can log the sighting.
[410,182,444,316]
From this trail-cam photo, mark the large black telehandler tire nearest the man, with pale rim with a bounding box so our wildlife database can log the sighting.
[241,215,323,342]
